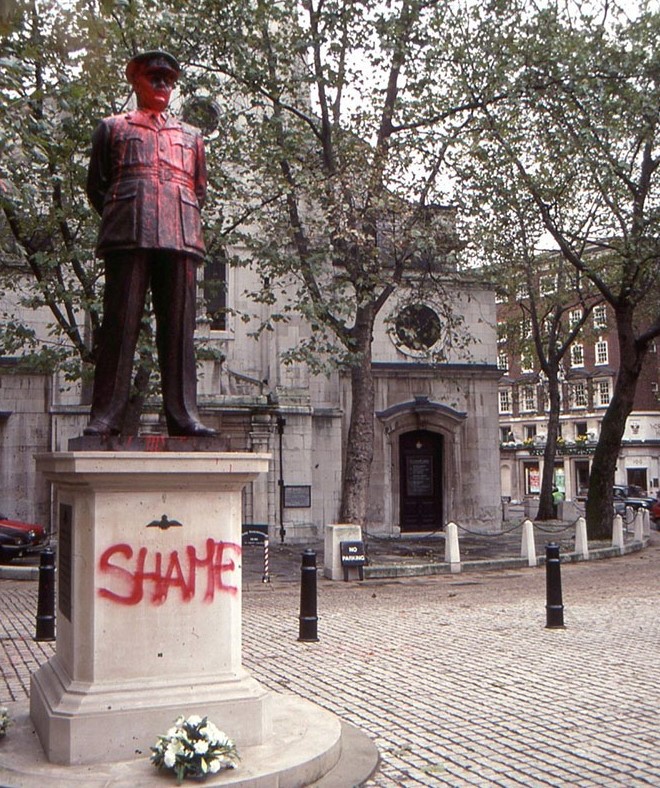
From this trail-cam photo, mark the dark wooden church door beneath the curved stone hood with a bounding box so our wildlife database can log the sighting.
[399,430,443,531]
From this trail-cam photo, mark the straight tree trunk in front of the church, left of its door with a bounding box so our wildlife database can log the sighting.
[339,310,374,525]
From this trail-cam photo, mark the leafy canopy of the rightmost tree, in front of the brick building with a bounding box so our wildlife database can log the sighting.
[454,2,660,320]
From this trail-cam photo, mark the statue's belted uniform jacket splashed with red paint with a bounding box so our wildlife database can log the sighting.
[87,110,206,257]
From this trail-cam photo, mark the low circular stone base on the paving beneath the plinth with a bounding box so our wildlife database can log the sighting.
[0,695,378,788]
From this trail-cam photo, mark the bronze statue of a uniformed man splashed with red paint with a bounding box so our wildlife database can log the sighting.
[85,51,215,436]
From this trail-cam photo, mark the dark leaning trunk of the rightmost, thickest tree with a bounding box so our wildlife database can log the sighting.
[586,310,647,539]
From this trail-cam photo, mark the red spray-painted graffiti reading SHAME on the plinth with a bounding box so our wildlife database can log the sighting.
[98,539,241,605]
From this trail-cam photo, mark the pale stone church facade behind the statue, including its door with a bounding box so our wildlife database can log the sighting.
[0,252,501,543]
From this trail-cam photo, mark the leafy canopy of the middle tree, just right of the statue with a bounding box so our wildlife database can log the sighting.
[164,0,472,368]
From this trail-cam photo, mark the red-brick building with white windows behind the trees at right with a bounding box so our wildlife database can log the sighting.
[498,304,660,500]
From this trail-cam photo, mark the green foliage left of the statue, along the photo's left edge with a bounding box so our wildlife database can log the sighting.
[0,2,115,376]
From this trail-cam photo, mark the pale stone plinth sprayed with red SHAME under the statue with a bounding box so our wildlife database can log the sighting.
[30,451,272,764]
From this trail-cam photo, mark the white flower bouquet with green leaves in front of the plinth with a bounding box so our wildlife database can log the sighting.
[151,714,239,785]
